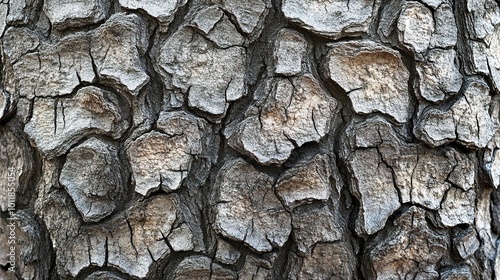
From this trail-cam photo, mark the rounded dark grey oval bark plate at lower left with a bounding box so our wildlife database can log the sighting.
[59,138,124,222]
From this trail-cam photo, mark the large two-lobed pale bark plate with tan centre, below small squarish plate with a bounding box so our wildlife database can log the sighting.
[228,75,339,165]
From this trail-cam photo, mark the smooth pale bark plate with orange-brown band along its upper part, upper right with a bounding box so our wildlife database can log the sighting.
[324,41,410,123]
